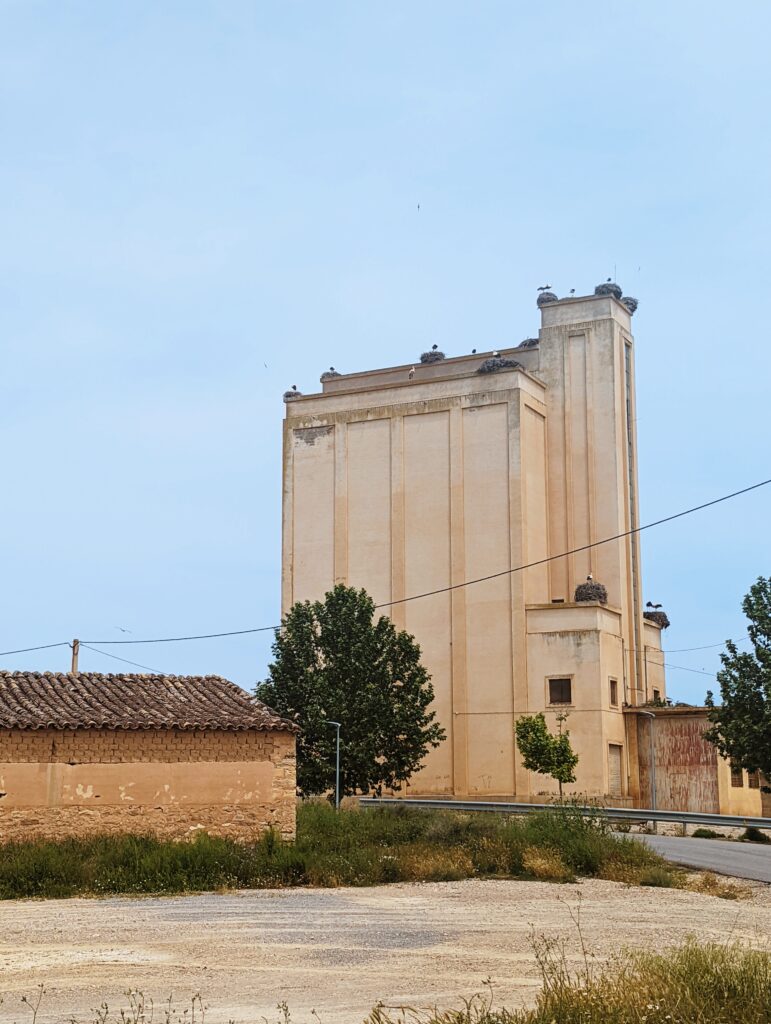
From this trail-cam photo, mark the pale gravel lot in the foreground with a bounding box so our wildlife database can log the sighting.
[0,880,771,1024]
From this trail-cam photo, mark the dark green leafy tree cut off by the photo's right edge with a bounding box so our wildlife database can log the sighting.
[705,577,771,793]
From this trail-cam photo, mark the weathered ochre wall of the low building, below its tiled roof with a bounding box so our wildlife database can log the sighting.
[0,729,295,839]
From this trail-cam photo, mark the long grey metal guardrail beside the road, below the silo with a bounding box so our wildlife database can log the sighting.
[359,797,771,828]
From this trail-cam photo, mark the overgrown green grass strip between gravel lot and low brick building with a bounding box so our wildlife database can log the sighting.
[0,802,677,899]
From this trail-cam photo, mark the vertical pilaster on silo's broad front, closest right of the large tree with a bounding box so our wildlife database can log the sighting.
[449,406,469,796]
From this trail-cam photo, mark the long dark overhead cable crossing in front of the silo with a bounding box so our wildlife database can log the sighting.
[0,477,771,651]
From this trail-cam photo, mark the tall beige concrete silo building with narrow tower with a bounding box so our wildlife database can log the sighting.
[283,288,666,799]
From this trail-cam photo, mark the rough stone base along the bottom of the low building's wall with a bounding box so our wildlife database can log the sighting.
[0,794,295,843]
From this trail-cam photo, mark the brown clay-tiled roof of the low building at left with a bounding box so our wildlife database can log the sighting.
[0,669,297,732]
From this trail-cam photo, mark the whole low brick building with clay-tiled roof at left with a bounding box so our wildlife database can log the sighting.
[0,672,296,840]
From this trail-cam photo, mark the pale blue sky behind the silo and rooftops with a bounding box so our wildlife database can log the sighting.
[0,0,771,702]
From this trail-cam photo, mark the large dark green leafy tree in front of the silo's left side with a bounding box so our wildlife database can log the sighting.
[255,584,445,796]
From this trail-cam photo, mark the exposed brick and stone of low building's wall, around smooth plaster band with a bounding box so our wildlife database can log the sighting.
[0,729,296,842]
